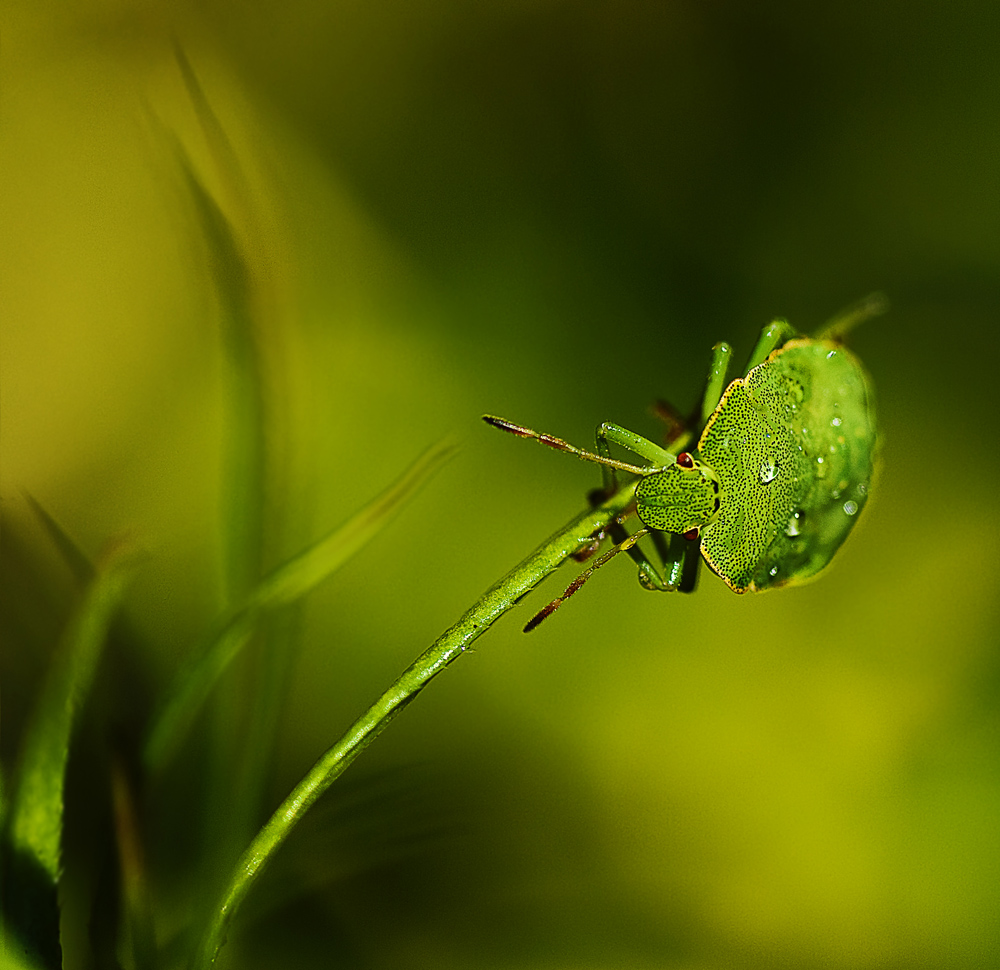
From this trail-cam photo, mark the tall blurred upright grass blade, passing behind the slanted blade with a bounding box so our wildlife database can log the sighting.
[167,49,278,855]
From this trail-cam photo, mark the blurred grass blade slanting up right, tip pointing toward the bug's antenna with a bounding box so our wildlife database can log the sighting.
[143,441,455,772]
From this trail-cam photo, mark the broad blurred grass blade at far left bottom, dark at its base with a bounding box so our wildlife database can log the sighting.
[3,546,128,968]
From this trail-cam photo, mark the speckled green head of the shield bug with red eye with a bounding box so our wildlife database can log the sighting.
[635,451,719,534]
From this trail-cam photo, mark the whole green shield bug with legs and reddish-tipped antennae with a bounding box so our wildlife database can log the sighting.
[484,298,883,629]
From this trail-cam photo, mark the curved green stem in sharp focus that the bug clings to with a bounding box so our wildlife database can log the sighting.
[194,483,635,970]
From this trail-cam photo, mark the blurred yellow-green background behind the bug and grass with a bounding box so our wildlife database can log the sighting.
[0,0,1000,970]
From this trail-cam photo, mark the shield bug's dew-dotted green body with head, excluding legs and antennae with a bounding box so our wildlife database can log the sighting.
[636,338,875,593]
